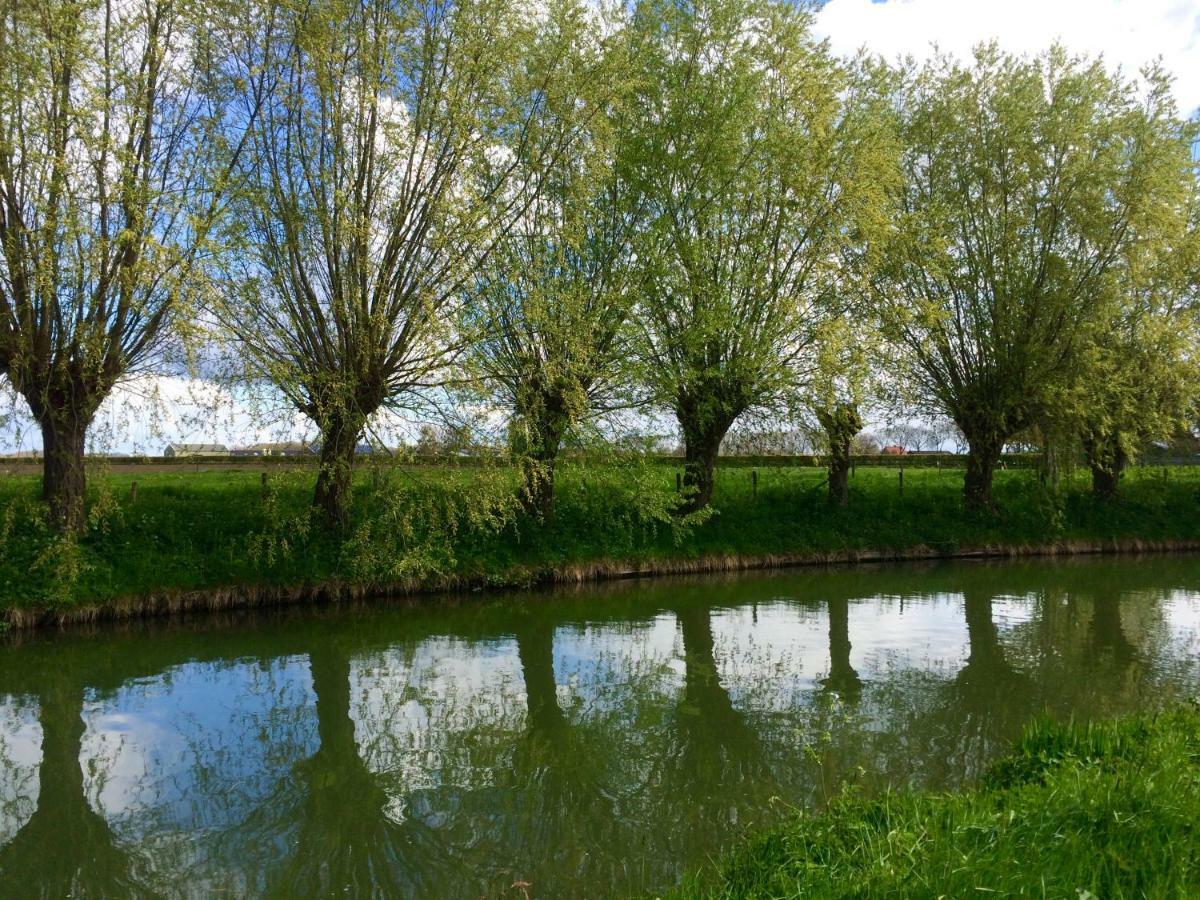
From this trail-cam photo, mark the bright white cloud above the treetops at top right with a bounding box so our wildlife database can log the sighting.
[817,0,1200,113]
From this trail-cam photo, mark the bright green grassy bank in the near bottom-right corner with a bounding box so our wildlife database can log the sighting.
[680,708,1200,899]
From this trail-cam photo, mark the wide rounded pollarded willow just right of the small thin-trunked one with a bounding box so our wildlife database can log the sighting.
[874,46,1192,506]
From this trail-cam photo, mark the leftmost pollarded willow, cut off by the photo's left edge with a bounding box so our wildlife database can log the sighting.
[0,0,254,532]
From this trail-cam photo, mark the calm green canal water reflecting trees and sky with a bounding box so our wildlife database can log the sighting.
[0,557,1200,898]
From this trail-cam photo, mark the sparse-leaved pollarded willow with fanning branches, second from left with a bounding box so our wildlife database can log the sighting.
[221,0,595,524]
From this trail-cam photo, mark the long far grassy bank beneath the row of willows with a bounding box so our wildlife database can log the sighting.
[0,464,1200,614]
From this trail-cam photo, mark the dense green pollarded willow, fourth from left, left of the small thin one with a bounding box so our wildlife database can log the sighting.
[625,0,897,510]
